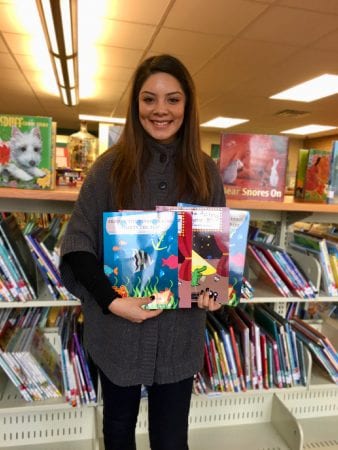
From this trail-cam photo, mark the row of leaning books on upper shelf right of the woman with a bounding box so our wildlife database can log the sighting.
[247,222,338,308]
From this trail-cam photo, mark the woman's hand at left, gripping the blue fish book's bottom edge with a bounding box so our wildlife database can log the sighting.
[108,297,163,323]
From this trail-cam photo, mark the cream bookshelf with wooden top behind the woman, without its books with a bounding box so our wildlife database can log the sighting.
[0,188,338,450]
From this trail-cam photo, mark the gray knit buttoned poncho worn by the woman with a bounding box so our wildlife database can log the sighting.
[60,141,225,386]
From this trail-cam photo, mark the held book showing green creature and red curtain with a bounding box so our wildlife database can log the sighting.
[178,203,230,304]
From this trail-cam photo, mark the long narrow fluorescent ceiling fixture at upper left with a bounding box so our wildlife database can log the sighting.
[36,0,79,106]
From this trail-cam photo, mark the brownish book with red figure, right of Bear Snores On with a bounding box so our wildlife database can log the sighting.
[295,149,330,203]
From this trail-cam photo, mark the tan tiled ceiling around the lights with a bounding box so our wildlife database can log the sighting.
[0,0,338,136]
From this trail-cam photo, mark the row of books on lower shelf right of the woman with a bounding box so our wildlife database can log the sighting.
[194,304,338,394]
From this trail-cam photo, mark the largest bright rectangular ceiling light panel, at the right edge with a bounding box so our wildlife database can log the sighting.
[270,73,338,102]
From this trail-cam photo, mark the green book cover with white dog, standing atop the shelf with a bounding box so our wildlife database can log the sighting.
[0,114,55,189]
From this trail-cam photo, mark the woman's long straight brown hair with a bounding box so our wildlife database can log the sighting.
[111,55,211,209]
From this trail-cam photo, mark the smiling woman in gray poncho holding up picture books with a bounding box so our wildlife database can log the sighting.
[61,55,225,450]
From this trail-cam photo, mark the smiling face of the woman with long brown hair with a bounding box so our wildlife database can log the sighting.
[138,72,186,143]
